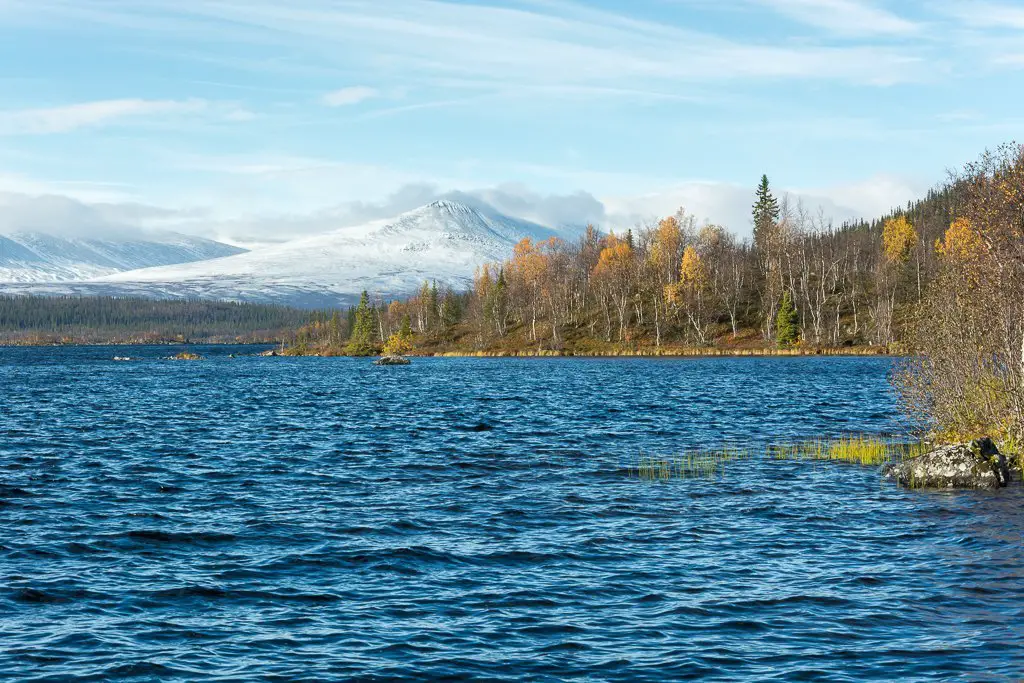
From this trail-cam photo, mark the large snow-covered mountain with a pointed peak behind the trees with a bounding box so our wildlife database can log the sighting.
[5,200,569,307]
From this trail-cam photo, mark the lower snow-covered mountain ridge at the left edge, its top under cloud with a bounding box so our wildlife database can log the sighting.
[0,231,245,283]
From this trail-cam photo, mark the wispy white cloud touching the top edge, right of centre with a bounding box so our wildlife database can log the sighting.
[752,0,922,36]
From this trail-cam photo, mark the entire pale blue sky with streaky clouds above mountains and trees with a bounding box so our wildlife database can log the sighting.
[0,0,1024,244]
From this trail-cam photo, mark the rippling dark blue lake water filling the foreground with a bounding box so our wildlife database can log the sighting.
[0,347,1024,681]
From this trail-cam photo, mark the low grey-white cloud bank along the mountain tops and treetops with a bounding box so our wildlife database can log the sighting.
[0,177,927,247]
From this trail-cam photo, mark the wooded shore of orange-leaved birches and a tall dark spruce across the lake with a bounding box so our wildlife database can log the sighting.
[293,172,958,354]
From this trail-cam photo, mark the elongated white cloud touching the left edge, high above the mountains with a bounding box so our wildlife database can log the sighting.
[0,99,210,135]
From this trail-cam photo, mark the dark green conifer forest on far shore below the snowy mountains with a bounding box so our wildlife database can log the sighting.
[0,296,311,344]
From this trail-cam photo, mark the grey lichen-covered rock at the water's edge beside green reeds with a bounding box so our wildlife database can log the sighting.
[883,438,1010,488]
